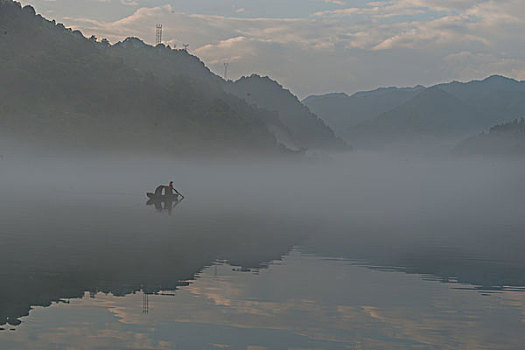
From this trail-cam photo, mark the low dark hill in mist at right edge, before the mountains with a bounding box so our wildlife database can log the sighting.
[455,118,525,156]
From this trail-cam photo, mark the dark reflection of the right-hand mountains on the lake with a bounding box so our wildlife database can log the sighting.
[303,218,525,290]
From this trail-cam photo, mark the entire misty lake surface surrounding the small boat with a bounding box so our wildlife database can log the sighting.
[0,152,525,349]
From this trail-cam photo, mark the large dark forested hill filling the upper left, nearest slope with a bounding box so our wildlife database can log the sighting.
[0,0,342,154]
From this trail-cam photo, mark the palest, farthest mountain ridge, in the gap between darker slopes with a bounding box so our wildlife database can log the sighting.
[303,86,424,138]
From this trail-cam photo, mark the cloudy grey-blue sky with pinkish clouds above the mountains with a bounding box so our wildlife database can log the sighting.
[21,0,525,98]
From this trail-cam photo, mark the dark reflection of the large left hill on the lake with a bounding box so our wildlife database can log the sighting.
[0,198,300,324]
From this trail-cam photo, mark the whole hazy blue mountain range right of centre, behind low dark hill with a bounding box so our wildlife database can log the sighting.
[304,75,525,148]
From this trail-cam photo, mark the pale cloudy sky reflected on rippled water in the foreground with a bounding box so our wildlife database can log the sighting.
[6,250,525,349]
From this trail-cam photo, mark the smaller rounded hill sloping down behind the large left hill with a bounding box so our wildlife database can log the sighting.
[227,75,345,150]
